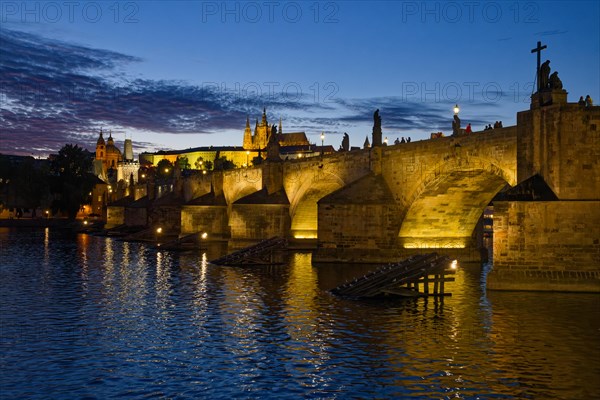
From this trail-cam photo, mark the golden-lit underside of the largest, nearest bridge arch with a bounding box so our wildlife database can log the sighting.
[398,157,516,248]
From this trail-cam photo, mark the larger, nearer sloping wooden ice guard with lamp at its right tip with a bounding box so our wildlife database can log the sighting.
[331,253,456,298]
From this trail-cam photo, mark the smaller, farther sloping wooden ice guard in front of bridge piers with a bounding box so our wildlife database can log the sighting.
[210,236,287,266]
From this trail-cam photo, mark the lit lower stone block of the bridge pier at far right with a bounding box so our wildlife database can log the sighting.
[487,201,600,292]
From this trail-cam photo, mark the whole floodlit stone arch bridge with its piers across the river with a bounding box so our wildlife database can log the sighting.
[143,101,600,292]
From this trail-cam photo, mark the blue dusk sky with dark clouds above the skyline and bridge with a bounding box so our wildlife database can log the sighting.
[0,1,600,156]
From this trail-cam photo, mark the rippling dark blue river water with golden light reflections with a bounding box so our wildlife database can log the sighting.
[0,228,600,399]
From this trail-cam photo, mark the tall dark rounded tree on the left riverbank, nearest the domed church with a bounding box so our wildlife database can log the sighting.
[50,144,96,220]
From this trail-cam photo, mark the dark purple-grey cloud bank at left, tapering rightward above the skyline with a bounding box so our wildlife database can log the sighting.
[0,29,324,154]
